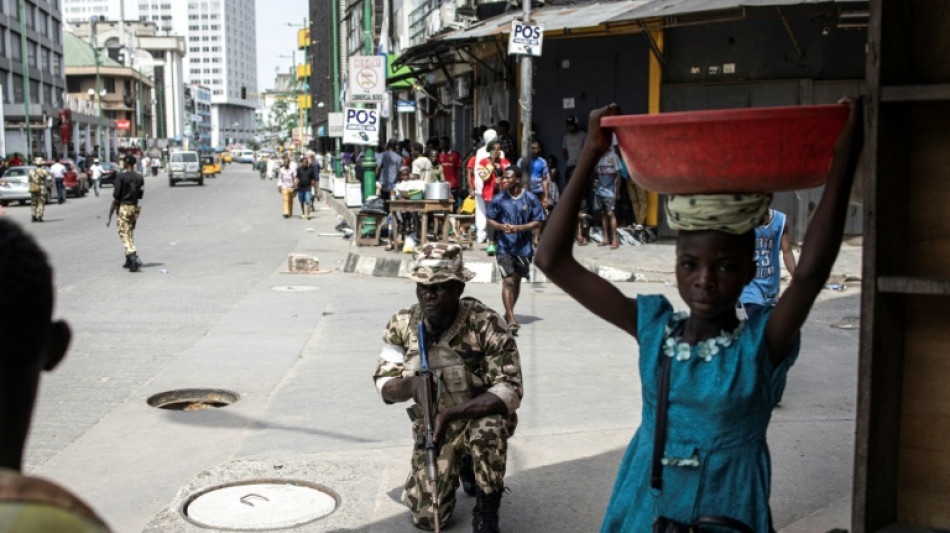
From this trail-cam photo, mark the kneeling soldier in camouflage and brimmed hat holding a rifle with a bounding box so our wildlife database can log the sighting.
[373,243,523,532]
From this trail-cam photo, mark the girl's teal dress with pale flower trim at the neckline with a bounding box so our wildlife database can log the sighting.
[601,295,800,533]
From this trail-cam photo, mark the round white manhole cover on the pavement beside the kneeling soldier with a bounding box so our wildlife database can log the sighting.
[181,480,339,531]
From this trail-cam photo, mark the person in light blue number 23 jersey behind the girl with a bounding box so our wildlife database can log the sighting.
[739,194,795,317]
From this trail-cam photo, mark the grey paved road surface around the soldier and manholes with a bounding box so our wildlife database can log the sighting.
[7,165,858,532]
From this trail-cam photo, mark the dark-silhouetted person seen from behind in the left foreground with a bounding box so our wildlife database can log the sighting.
[0,217,109,533]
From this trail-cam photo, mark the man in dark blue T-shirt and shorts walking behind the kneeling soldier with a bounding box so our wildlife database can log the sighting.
[486,166,544,334]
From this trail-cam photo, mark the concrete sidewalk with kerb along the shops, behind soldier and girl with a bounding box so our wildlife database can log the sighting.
[326,190,862,287]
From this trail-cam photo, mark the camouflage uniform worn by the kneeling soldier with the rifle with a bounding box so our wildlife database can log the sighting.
[374,296,523,529]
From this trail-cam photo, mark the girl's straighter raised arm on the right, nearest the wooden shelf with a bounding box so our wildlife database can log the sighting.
[765,98,864,366]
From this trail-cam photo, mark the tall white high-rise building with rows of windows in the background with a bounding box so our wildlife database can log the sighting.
[62,0,258,146]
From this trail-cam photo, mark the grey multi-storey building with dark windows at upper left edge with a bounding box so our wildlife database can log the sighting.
[0,0,66,156]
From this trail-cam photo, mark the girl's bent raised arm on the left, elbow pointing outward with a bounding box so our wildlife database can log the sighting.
[535,104,637,337]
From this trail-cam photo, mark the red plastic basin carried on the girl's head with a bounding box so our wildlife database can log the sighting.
[601,104,849,194]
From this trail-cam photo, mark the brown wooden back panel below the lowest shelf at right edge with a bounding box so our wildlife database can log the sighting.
[897,296,950,529]
